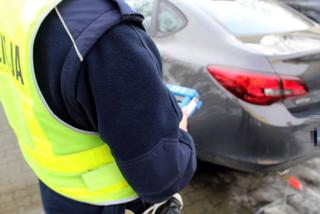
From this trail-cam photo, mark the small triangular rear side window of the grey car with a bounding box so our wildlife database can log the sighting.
[157,0,187,36]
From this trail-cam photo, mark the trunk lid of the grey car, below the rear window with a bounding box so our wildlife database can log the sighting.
[239,30,320,117]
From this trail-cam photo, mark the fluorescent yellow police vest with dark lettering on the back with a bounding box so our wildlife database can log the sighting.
[0,0,137,205]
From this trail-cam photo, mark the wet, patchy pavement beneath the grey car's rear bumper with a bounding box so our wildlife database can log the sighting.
[183,159,320,214]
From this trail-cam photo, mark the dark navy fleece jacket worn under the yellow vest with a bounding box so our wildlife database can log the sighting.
[34,0,196,206]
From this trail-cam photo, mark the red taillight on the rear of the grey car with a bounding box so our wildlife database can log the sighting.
[208,66,307,105]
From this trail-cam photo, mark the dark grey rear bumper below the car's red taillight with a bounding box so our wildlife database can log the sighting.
[190,93,320,172]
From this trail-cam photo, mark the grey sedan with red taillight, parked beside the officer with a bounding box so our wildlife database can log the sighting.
[128,0,320,171]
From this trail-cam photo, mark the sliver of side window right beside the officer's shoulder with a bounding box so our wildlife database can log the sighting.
[125,0,154,31]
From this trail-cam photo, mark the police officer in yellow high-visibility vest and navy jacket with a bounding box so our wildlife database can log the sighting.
[0,0,196,214]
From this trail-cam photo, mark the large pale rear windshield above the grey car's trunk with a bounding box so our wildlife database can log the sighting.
[198,0,311,36]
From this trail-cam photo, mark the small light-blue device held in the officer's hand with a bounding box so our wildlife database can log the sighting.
[167,84,202,117]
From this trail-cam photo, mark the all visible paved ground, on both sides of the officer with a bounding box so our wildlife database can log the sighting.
[0,105,320,214]
